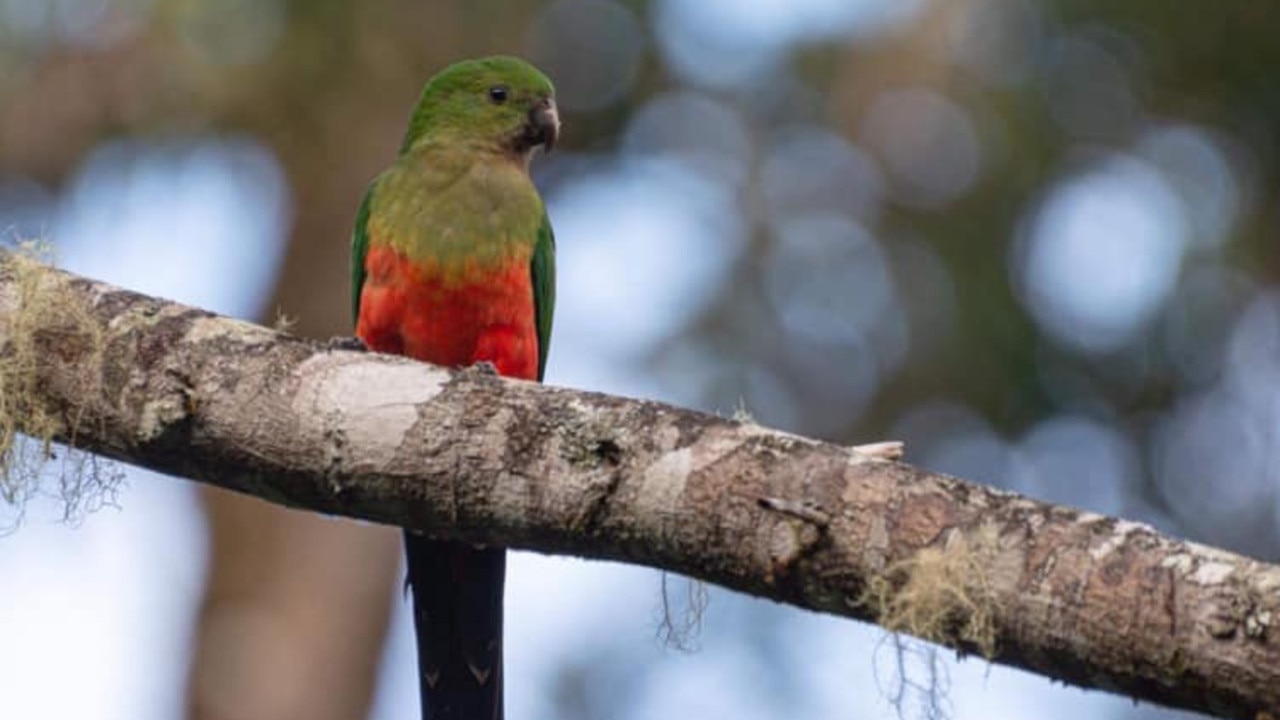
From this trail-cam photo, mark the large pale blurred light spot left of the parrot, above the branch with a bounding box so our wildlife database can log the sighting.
[49,140,289,318]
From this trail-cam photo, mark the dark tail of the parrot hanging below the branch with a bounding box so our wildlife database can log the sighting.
[404,530,507,720]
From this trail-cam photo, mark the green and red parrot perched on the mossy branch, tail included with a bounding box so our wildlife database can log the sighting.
[351,56,561,720]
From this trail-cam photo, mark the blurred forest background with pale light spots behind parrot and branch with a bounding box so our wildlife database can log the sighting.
[0,0,1280,720]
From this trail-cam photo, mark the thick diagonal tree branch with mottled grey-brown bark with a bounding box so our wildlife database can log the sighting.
[0,258,1280,719]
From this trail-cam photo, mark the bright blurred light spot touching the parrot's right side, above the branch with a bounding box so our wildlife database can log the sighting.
[550,159,741,391]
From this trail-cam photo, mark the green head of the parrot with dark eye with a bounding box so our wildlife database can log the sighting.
[401,56,558,155]
